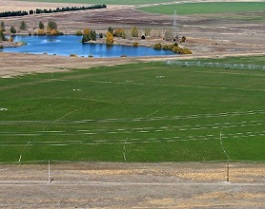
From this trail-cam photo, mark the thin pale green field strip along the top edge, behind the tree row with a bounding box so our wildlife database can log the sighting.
[21,0,175,5]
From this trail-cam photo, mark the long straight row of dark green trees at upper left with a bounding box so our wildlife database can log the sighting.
[0,4,107,17]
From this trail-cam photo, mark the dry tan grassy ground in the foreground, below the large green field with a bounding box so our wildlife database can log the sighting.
[0,163,265,209]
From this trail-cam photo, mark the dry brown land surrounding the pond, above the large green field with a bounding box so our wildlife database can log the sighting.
[0,0,265,77]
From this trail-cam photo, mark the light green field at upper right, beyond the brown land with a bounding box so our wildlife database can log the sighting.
[140,2,265,15]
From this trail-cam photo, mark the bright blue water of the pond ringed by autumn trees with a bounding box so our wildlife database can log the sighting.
[1,35,173,57]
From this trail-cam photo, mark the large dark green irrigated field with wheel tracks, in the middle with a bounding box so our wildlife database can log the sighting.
[0,56,265,163]
